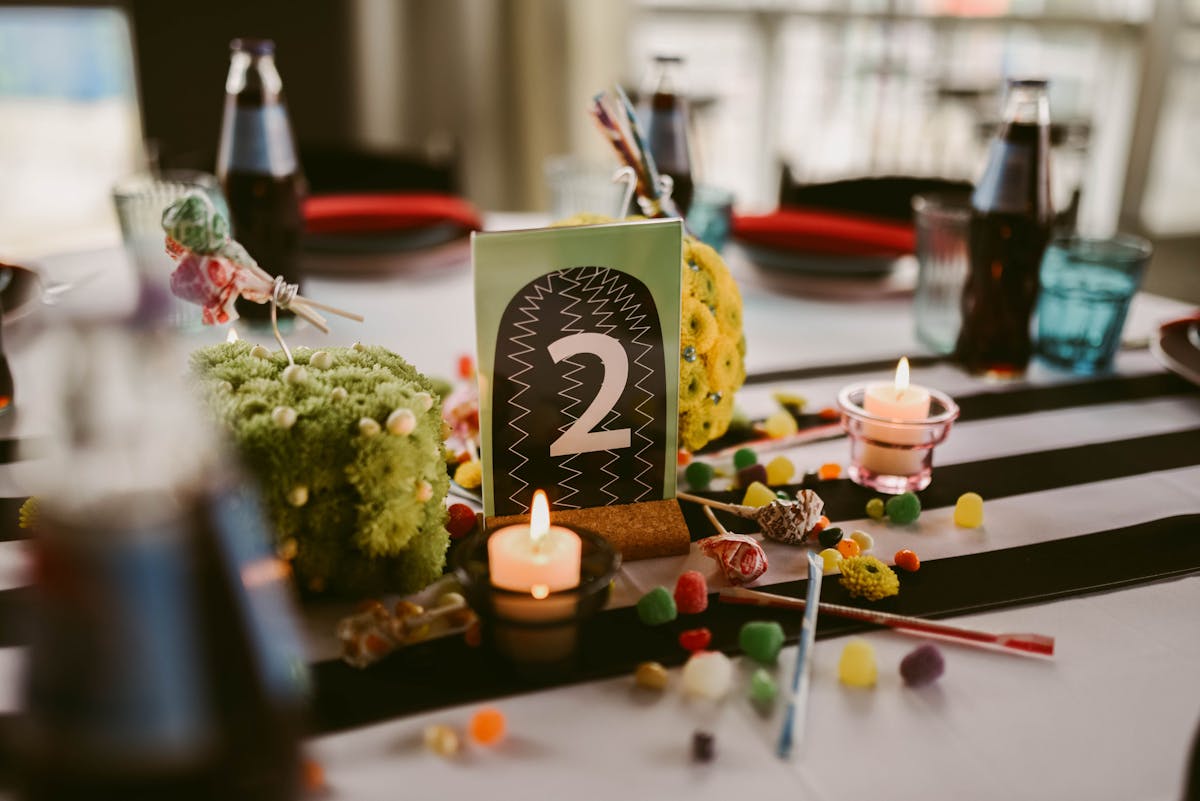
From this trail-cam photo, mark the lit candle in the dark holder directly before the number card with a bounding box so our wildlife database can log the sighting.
[487,489,583,598]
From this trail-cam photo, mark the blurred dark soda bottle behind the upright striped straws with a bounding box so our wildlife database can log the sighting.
[638,55,695,216]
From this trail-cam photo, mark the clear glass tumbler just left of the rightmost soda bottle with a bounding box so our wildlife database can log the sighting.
[912,192,971,354]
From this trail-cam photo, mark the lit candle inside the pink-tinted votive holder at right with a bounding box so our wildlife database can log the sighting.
[862,359,930,476]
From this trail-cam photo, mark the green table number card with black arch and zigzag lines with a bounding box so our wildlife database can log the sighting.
[472,219,683,556]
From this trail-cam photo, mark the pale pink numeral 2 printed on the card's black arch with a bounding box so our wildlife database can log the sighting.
[547,333,629,456]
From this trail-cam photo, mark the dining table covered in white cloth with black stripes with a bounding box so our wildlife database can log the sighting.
[0,213,1200,801]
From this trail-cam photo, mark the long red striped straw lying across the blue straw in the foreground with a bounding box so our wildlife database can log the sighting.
[720,586,1054,657]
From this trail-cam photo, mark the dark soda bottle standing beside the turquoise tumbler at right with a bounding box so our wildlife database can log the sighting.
[955,80,1054,379]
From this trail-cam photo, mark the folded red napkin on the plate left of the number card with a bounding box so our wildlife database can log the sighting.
[304,194,484,234]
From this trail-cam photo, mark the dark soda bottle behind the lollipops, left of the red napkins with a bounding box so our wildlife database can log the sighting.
[217,38,304,323]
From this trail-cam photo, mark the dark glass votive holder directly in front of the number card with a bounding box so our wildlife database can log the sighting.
[454,526,620,680]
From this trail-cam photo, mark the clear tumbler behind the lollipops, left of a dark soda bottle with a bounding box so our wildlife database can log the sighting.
[113,170,229,331]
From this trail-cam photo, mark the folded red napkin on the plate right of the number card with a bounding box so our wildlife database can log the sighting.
[733,207,916,257]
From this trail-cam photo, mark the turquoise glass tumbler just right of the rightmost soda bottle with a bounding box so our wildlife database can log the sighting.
[1037,234,1152,374]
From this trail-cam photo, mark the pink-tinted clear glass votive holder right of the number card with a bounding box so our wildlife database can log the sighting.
[838,384,959,495]
